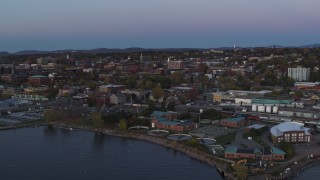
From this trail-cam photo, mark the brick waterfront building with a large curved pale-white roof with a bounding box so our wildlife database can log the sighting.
[270,122,311,143]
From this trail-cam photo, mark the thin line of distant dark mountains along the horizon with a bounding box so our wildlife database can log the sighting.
[0,44,320,57]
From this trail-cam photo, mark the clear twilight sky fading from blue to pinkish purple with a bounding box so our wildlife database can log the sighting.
[0,0,320,52]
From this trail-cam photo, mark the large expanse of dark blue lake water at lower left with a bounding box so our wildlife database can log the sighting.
[0,127,222,180]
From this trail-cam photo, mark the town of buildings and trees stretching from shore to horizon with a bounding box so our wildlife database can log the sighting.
[0,47,320,179]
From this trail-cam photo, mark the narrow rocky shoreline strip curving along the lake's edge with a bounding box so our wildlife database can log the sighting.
[4,122,320,179]
